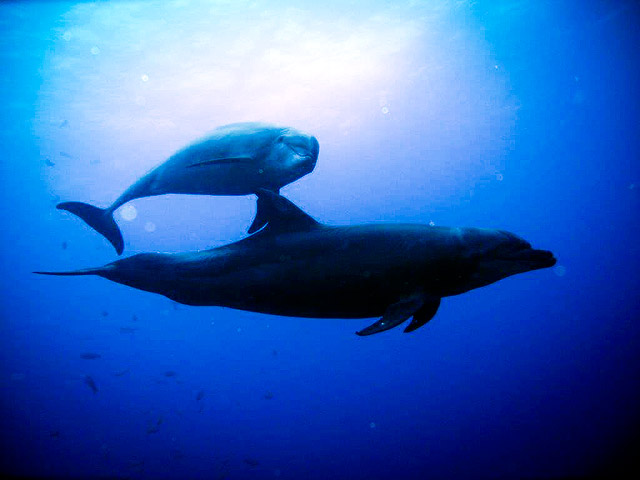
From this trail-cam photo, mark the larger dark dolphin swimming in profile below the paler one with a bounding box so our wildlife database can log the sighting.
[36,191,556,335]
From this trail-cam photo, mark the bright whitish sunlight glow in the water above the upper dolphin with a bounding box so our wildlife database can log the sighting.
[35,1,516,244]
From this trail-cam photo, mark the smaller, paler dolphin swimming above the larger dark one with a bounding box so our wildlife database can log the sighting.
[57,123,319,254]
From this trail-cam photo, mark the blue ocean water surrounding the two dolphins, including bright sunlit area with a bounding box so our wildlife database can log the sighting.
[0,0,640,479]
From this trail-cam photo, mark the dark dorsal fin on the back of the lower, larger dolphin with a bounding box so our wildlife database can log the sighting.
[249,188,320,234]
